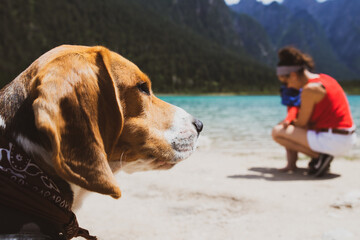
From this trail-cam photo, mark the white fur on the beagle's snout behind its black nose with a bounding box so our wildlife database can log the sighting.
[164,106,198,162]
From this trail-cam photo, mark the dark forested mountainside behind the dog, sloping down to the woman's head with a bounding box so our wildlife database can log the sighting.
[0,0,278,92]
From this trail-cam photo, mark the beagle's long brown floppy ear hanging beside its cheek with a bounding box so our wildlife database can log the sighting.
[32,49,124,198]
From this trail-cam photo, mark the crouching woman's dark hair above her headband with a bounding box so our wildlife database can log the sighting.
[277,46,315,71]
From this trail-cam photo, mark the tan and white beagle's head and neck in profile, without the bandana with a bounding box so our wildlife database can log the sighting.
[0,45,203,238]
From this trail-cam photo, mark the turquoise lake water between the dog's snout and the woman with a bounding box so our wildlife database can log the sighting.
[160,96,360,157]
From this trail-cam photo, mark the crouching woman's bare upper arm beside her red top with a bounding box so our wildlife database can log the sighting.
[294,83,326,128]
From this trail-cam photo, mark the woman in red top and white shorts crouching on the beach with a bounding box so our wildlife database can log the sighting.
[272,47,356,177]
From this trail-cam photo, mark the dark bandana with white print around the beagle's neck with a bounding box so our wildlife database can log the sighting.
[0,137,97,240]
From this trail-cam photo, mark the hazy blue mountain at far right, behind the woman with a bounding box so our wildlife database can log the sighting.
[230,0,360,79]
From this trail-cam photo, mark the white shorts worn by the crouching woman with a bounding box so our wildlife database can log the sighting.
[307,130,357,156]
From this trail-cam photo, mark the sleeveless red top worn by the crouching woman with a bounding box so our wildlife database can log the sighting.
[309,74,353,130]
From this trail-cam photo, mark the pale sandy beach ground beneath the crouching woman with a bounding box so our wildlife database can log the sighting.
[77,148,360,240]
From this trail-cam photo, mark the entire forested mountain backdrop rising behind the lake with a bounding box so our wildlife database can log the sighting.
[0,0,360,93]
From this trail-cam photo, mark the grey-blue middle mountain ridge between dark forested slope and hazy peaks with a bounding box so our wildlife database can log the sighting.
[134,0,276,65]
